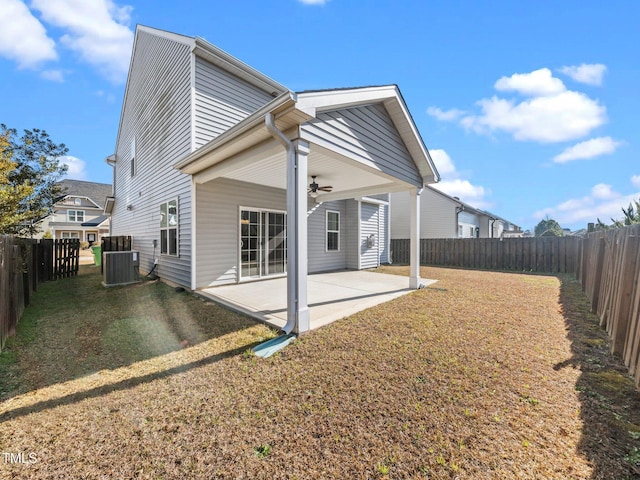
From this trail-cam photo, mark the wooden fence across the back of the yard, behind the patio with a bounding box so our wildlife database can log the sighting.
[391,237,581,273]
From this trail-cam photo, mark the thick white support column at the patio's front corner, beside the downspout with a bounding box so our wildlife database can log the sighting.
[287,139,310,333]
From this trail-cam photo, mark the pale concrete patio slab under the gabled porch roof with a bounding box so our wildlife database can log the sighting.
[196,270,436,330]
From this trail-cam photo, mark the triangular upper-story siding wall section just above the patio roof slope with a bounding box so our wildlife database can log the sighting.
[194,57,273,148]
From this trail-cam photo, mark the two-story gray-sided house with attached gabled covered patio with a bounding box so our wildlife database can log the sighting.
[107,26,438,331]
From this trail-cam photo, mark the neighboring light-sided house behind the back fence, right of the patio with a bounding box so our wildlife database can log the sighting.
[390,186,522,239]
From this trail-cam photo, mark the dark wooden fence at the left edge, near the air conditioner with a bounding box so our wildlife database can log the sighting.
[0,235,80,351]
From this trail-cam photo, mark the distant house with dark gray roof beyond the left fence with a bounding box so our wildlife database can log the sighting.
[38,180,112,244]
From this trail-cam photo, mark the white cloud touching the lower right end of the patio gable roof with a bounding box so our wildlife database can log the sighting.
[429,149,491,208]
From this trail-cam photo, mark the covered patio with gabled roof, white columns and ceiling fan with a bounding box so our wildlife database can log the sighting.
[176,85,439,333]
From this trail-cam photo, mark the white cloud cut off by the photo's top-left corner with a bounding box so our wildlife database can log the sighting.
[0,0,58,68]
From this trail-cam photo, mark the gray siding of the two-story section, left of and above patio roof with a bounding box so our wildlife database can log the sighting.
[112,32,272,286]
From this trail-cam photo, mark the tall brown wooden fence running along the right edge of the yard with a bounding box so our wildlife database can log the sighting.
[577,225,640,387]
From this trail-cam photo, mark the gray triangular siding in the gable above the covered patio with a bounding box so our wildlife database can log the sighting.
[302,104,422,186]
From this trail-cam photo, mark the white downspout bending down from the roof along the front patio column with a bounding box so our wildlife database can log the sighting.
[264,112,299,334]
